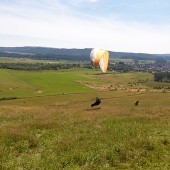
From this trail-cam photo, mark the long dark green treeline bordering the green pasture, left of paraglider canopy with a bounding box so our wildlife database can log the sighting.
[0,63,92,71]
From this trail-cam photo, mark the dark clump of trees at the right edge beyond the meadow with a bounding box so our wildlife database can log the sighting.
[154,72,170,82]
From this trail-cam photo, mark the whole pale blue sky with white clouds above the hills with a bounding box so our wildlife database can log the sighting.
[0,0,170,54]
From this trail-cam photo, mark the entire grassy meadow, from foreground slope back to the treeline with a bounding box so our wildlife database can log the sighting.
[0,69,170,170]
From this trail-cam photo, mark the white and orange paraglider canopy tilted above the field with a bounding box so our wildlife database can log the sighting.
[90,49,109,73]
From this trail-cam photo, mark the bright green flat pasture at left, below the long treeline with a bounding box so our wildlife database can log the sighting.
[0,69,93,97]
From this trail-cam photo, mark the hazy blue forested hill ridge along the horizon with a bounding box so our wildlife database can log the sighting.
[0,46,170,61]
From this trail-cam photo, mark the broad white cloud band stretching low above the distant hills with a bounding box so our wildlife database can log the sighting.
[0,0,170,53]
